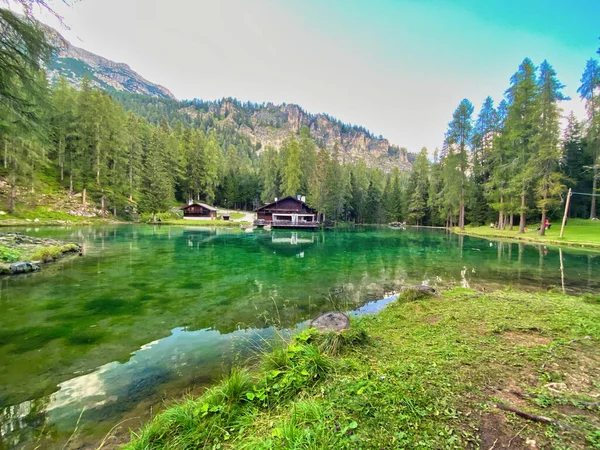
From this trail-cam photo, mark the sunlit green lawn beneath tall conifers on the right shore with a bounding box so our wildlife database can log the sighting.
[453,219,600,249]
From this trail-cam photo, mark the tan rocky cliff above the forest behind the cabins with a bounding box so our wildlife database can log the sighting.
[188,99,414,171]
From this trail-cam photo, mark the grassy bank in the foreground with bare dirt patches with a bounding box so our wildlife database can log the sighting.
[126,289,600,450]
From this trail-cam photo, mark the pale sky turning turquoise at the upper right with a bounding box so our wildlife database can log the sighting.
[16,0,600,151]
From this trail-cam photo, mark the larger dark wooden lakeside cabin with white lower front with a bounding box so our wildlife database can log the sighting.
[254,196,322,229]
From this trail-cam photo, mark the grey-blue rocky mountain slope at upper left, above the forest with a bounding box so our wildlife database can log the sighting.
[44,26,175,99]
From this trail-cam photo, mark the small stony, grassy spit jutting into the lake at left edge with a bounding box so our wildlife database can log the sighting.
[0,232,81,275]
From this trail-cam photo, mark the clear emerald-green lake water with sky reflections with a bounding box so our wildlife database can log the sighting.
[0,225,600,448]
